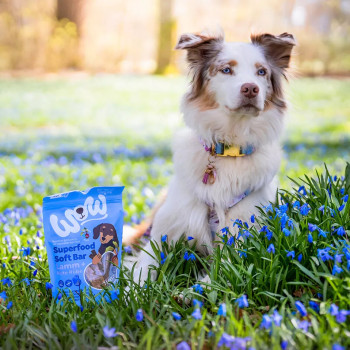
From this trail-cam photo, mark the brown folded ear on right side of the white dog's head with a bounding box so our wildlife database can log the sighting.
[250,33,296,70]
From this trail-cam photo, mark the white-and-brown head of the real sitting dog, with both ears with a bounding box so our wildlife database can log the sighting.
[176,33,295,142]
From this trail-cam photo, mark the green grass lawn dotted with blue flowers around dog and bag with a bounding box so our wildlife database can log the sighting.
[0,76,350,349]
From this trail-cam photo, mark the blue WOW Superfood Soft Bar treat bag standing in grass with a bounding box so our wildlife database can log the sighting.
[43,186,124,305]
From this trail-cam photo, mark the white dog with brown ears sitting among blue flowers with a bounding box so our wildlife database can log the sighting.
[134,33,295,284]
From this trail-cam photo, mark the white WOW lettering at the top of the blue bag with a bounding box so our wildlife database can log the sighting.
[50,194,108,237]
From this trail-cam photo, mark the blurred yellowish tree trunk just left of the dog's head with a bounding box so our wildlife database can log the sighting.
[155,0,176,74]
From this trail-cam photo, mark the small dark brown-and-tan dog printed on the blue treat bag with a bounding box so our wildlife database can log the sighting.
[90,224,119,265]
